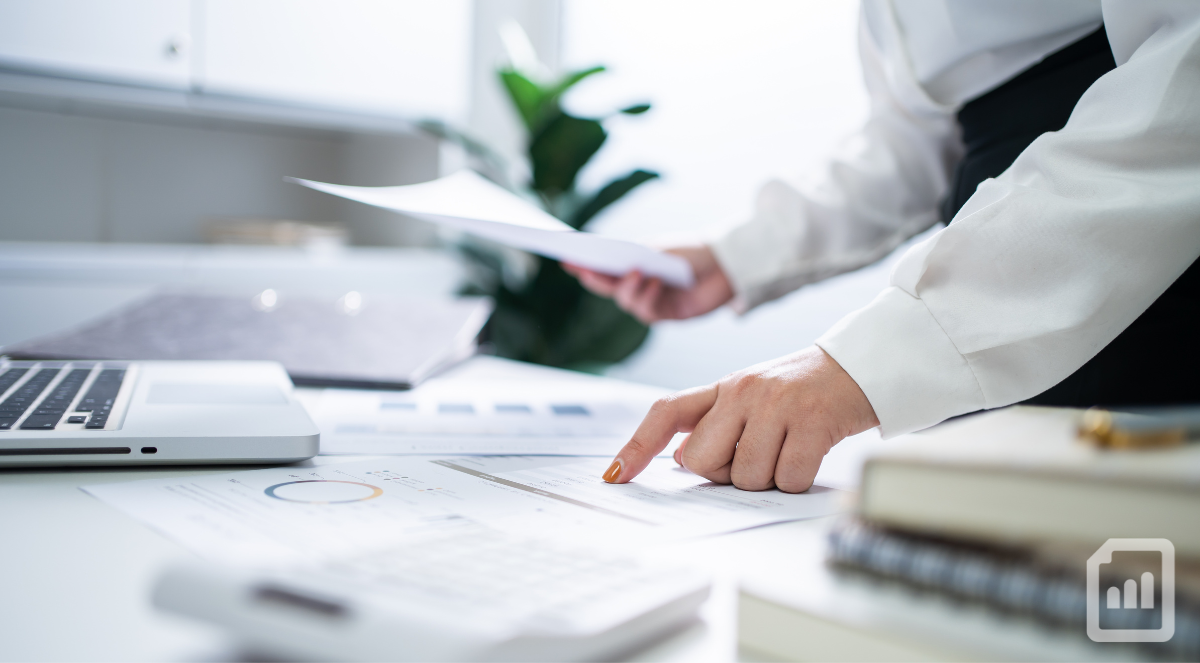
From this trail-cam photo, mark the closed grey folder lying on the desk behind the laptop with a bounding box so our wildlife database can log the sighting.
[2,293,492,389]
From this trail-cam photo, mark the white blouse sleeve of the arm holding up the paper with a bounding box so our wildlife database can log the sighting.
[712,12,961,312]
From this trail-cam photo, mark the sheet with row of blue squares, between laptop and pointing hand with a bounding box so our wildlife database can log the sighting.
[301,378,667,459]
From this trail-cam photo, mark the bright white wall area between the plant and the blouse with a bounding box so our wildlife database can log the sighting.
[563,0,866,238]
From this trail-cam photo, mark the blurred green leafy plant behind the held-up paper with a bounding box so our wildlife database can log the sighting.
[425,56,659,370]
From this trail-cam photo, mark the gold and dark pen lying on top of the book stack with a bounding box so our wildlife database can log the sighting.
[1079,407,1200,449]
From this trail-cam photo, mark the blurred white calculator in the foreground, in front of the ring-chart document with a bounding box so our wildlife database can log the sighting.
[154,526,709,661]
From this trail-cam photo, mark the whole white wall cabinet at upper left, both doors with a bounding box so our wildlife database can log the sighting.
[0,0,472,121]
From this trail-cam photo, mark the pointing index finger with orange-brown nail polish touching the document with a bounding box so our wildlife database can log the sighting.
[604,383,716,483]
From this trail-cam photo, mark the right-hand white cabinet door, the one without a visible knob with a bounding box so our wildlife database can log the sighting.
[197,0,470,120]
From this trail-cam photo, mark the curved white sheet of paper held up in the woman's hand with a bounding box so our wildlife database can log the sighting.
[288,171,694,287]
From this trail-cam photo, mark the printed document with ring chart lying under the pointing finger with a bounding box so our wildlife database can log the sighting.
[83,456,846,566]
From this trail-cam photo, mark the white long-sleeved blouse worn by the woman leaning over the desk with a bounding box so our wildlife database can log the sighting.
[713,0,1200,436]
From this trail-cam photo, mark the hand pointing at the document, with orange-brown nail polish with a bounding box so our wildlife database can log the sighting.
[604,346,880,492]
